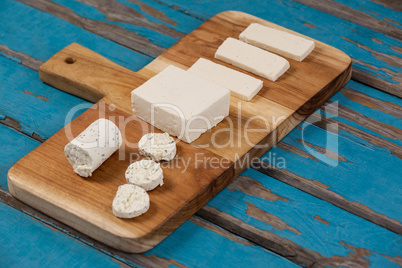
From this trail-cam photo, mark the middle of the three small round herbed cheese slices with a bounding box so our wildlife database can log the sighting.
[126,160,163,191]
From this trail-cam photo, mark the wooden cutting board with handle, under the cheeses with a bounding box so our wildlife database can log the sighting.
[8,11,351,252]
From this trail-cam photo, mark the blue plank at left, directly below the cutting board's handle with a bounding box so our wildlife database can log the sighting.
[0,56,92,139]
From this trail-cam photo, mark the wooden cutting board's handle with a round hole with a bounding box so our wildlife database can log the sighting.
[39,43,145,112]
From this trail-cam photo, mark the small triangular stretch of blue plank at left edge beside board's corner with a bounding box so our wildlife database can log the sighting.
[0,124,40,189]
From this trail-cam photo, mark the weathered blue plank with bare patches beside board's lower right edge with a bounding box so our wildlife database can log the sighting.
[206,169,402,267]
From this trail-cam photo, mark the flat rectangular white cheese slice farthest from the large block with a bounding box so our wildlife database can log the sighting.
[239,23,314,61]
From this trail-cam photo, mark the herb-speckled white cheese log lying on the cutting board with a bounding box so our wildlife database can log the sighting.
[64,118,123,177]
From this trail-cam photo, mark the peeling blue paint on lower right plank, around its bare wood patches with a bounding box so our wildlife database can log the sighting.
[206,169,402,267]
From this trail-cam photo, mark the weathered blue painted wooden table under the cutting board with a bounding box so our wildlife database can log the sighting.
[0,0,402,267]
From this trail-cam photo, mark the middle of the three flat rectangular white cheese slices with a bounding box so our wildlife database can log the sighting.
[215,37,290,81]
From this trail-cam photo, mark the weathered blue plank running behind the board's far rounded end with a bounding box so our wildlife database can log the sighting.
[156,0,402,87]
